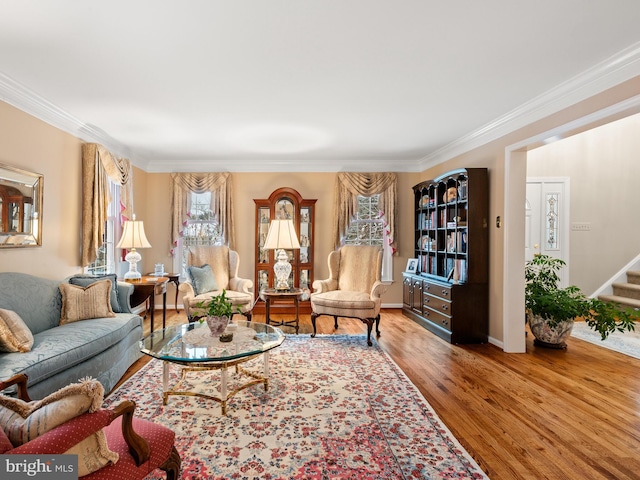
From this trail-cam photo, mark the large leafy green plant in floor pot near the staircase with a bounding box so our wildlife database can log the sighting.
[525,254,638,348]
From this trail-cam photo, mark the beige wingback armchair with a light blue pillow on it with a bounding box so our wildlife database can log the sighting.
[178,246,253,322]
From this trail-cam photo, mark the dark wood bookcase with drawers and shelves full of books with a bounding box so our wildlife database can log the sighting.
[402,168,489,343]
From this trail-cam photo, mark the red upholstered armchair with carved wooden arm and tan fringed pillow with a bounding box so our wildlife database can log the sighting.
[0,374,181,480]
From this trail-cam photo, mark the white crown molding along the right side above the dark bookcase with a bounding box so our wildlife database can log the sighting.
[418,42,640,171]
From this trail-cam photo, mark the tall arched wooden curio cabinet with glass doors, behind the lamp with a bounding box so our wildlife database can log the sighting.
[253,187,316,314]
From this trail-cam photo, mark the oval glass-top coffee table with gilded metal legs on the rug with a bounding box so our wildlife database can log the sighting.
[140,321,285,415]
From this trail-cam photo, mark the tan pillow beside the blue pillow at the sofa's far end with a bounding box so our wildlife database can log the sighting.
[59,280,116,325]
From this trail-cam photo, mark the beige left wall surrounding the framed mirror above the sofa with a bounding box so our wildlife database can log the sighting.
[0,102,82,279]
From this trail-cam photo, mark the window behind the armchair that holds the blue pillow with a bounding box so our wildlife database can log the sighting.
[174,192,224,278]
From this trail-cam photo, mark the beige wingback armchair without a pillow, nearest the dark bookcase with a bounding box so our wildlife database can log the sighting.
[311,245,386,345]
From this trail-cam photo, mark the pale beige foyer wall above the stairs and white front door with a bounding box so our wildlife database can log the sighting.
[527,114,640,295]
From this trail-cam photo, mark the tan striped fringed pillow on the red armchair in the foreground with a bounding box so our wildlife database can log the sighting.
[0,378,118,477]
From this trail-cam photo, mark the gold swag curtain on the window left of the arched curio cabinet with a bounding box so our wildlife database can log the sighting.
[171,172,235,255]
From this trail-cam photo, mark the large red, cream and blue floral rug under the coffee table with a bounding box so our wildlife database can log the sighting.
[105,335,487,480]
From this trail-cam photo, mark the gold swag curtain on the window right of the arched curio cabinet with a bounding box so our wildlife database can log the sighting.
[333,172,398,253]
